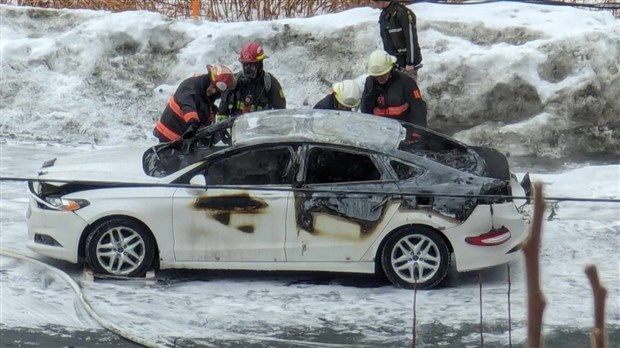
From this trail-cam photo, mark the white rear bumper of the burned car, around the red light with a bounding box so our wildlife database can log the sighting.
[445,202,529,272]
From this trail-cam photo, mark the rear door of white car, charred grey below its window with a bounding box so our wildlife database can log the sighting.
[286,145,399,262]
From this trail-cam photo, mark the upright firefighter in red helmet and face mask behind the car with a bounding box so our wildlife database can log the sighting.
[217,42,286,121]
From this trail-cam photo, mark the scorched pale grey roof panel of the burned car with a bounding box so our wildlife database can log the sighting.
[232,109,406,150]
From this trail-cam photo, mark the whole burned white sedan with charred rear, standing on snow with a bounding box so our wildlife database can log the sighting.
[27,110,529,289]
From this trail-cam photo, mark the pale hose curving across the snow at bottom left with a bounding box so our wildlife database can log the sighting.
[0,248,164,348]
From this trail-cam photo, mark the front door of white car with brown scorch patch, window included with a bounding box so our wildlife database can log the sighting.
[173,146,295,262]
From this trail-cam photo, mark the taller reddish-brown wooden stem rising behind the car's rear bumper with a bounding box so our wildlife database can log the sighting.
[522,182,547,348]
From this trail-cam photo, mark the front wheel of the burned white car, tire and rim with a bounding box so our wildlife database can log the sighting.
[85,218,155,277]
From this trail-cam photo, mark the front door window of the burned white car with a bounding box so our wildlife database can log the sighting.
[206,147,293,185]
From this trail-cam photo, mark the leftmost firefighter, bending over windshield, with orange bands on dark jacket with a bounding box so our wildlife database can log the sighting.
[153,65,235,143]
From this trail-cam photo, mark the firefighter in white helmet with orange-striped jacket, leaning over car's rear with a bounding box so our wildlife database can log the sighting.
[362,50,427,127]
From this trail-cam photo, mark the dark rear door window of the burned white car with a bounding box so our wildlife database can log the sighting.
[306,147,381,184]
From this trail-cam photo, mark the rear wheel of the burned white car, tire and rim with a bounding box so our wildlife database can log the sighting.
[381,226,451,289]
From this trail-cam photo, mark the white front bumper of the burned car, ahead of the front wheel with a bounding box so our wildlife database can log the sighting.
[26,199,87,263]
